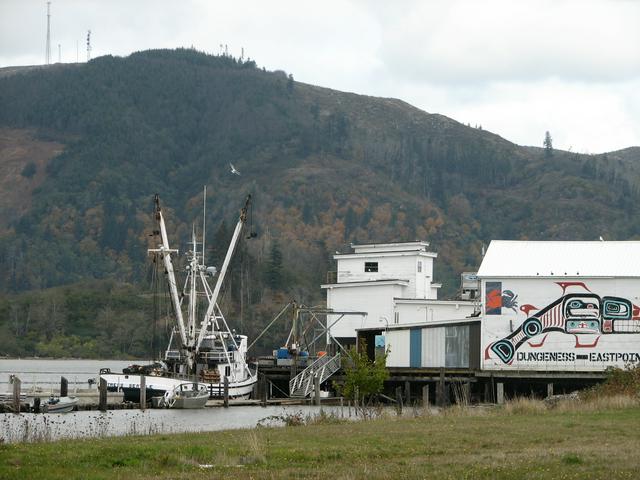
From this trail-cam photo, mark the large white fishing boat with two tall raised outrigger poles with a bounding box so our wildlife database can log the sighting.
[100,189,257,402]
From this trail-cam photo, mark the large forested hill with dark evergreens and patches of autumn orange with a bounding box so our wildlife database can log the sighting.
[0,50,640,353]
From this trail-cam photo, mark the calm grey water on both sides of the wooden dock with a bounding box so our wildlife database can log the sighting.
[0,359,350,443]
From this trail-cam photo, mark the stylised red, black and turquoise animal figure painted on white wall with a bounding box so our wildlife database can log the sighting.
[485,282,640,364]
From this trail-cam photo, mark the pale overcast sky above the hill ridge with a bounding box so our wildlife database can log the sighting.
[0,0,640,153]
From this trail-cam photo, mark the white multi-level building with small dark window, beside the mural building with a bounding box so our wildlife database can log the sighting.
[322,242,474,350]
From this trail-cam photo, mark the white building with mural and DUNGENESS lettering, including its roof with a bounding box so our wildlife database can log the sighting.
[478,240,640,371]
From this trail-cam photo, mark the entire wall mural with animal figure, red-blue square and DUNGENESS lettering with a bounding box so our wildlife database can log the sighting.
[484,282,640,365]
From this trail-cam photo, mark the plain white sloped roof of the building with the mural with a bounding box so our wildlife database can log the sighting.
[478,240,640,278]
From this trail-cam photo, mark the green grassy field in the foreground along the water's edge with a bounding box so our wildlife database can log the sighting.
[0,401,640,480]
